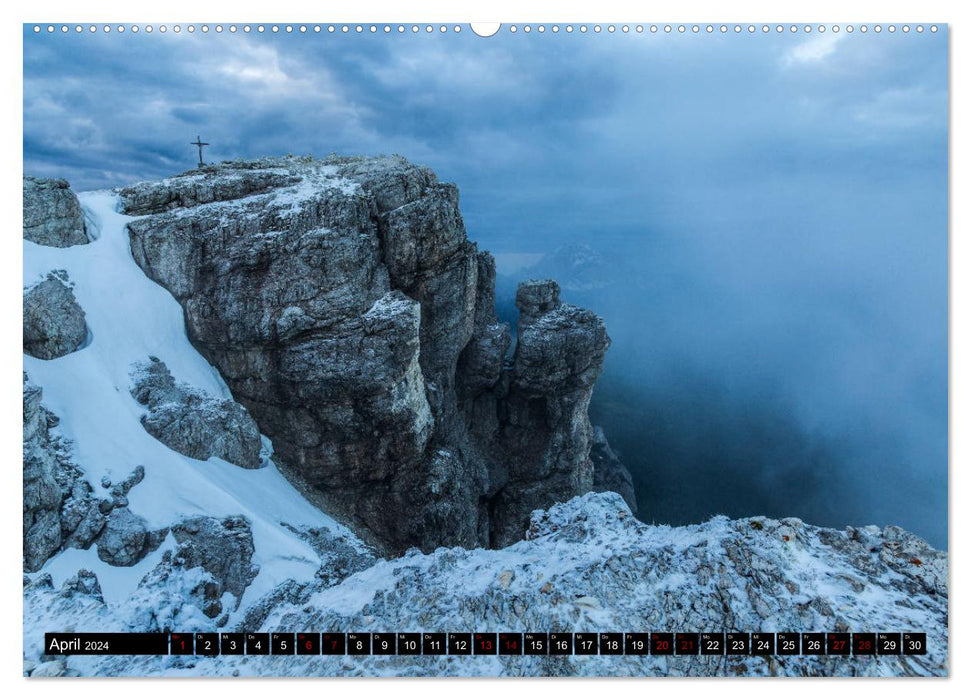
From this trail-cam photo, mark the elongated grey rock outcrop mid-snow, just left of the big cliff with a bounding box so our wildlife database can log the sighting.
[131,357,262,469]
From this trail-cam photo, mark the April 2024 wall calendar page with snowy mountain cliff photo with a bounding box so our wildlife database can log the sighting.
[22,20,949,678]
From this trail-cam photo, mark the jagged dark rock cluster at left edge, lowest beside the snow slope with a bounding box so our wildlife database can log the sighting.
[23,374,153,571]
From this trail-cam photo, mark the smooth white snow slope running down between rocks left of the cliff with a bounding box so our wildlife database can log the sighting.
[23,192,364,628]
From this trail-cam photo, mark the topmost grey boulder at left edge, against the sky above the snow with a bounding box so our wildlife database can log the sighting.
[24,175,88,248]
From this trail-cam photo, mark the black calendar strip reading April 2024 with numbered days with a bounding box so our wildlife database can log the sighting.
[44,632,927,656]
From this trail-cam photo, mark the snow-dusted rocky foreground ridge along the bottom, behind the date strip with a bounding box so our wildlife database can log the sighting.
[24,493,948,676]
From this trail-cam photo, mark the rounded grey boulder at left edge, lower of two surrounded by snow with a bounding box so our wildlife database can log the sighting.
[24,274,88,360]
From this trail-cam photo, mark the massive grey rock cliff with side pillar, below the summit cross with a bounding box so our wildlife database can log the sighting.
[121,157,608,551]
